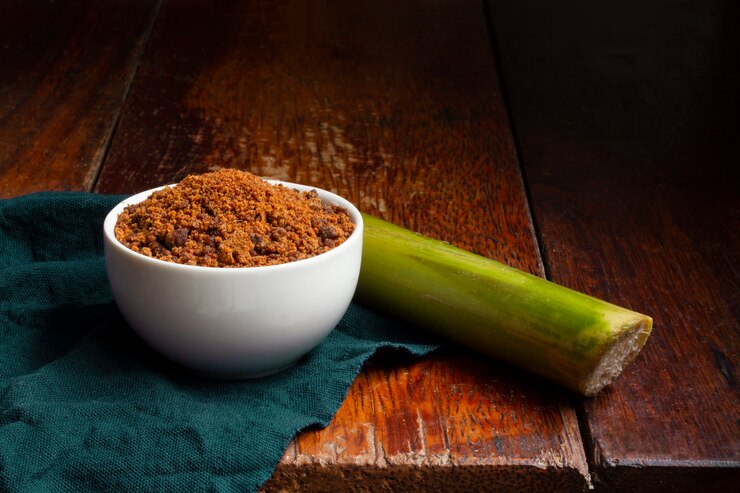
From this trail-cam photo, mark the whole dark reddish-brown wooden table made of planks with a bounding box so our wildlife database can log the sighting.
[0,0,740,492]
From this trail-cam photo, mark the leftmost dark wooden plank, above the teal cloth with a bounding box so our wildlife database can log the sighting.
[0,0,158,197]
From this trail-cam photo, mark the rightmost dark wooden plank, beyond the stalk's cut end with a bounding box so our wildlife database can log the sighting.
[489,0,740,492]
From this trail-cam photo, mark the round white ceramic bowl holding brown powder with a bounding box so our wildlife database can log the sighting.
[103,182,363,378]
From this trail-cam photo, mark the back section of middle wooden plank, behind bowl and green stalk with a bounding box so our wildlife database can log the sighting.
[96,1,542,266]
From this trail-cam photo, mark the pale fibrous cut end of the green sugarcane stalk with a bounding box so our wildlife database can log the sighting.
[580,316,653,397]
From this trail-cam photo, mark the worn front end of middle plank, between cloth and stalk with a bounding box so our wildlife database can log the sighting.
[266,350,586,492]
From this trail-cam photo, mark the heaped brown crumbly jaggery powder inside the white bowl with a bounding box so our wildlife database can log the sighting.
[115,169,354,267]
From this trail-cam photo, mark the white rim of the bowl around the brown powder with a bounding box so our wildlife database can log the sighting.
[103,178,363,275]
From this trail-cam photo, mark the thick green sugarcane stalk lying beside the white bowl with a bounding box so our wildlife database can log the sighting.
[355,215,652,396]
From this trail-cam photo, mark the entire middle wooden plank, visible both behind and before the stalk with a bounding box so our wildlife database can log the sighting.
[97,0,588,491]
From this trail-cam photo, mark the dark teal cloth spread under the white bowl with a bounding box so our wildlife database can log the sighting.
[0,192,435,493]
